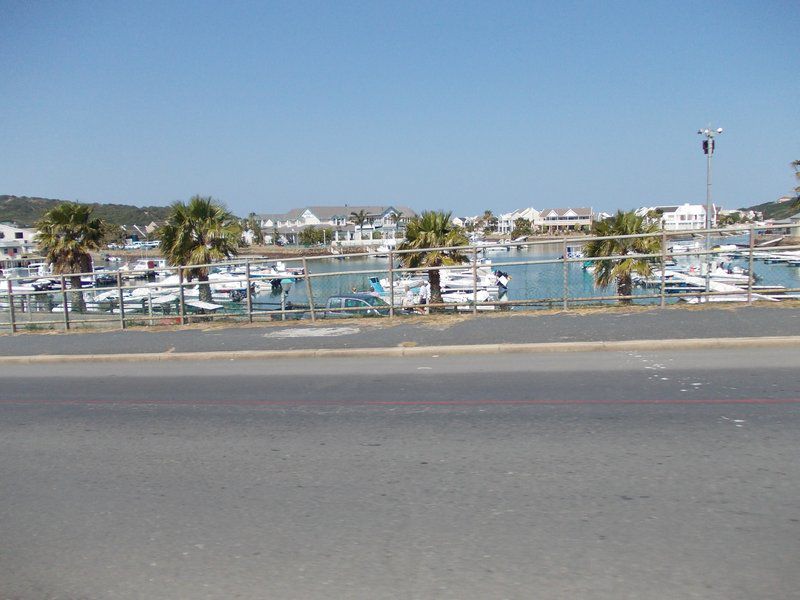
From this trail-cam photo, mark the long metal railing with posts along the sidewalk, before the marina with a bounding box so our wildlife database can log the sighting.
[0,226,800,333]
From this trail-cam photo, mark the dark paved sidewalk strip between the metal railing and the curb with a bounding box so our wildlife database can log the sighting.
[0,306,800,357]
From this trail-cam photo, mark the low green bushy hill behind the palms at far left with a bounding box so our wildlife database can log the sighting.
[0,196,175,227]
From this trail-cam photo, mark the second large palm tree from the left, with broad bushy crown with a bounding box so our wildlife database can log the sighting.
[158,196,242,302]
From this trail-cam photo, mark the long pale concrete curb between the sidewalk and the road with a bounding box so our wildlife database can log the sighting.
[0,336,800,365]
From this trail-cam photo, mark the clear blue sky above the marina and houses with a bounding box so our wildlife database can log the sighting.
[0,0,800,218]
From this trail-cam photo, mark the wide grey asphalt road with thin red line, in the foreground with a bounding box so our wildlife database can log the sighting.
[0,349,800,600]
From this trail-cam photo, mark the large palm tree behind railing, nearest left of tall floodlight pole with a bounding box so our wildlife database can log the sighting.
[584,211,661,304]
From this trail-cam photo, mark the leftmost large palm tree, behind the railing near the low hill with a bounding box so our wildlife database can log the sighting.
[36,202,105,313]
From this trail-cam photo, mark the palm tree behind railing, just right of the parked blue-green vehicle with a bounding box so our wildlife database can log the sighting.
[398,211,469,304]
